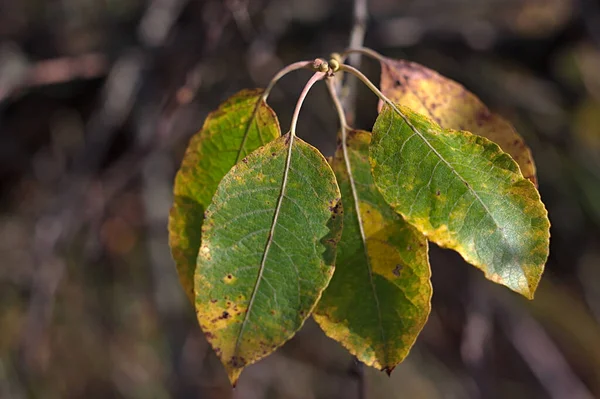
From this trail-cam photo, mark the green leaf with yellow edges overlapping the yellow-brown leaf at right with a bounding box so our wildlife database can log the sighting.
[369,106,550,299]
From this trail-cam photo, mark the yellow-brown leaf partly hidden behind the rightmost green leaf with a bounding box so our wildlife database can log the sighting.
[380,57,537,185]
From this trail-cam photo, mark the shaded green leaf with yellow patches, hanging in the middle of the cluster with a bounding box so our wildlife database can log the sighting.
[314,131,431,372]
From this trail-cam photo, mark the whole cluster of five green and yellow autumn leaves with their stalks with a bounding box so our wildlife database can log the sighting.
[169,49,550,384]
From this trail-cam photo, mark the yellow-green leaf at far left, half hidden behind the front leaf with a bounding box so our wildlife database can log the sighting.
[169,90,281,303]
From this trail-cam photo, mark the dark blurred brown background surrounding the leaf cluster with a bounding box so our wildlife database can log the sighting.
[0,0,600,399]
